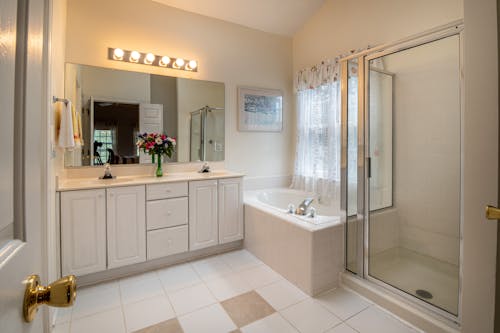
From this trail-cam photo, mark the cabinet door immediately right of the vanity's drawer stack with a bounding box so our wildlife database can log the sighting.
[189,180,219,251]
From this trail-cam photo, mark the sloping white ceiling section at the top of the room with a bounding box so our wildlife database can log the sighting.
[153,0,325,36]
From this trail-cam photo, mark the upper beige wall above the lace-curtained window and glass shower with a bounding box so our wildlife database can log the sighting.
[293,0,463,72]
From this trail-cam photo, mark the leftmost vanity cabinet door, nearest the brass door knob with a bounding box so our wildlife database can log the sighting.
[61,190,106,275]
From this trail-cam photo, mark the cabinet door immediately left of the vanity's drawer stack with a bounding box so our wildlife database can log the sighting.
[106,185,146,268]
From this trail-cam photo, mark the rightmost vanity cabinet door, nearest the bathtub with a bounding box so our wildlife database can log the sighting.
[218,178,243,244]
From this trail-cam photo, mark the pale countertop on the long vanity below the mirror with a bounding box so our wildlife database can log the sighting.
[57,170,244,192]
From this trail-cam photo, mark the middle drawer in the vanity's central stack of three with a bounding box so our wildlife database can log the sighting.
[147,197,188,230]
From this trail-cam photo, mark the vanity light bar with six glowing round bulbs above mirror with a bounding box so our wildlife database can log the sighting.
[108,47,198,72]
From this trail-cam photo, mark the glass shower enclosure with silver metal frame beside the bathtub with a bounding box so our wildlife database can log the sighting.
[341,26,463,321]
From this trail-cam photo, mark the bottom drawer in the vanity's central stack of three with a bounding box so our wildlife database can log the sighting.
[147,225,188,260]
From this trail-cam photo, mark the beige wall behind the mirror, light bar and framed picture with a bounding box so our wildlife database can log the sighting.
[66,0,294,182]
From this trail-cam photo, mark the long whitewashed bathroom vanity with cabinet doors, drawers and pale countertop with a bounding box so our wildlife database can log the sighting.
[58,171,243,283]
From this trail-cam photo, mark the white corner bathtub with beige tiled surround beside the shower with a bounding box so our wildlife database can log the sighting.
[244,188,344,296]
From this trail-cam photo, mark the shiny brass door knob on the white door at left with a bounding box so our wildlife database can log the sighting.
[23,275,76,323]
